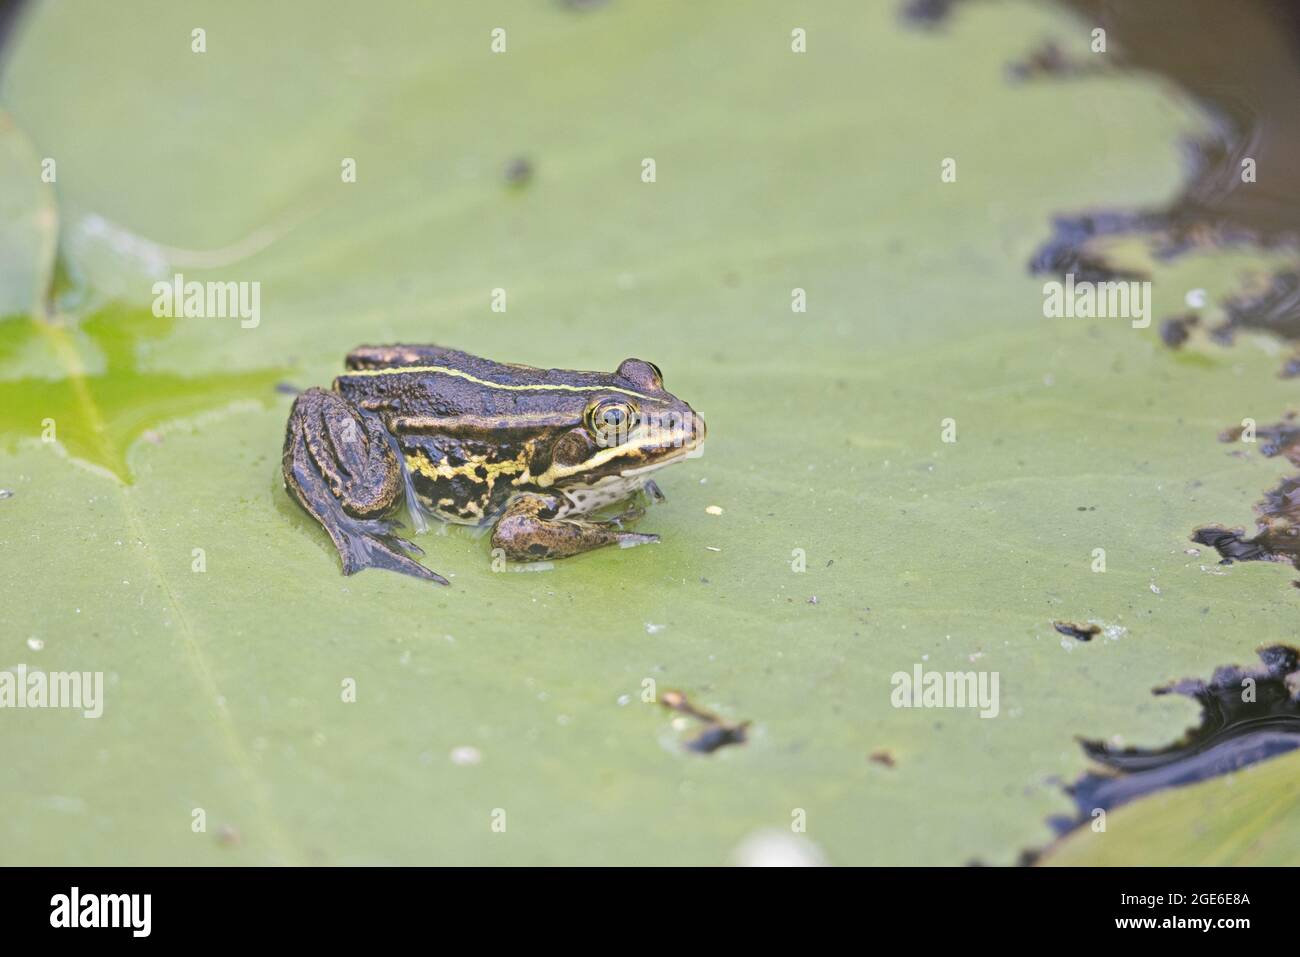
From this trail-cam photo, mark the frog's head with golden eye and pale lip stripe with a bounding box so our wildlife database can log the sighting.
[540,359,706,489]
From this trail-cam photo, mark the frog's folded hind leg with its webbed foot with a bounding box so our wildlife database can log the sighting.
[283,389,450,585]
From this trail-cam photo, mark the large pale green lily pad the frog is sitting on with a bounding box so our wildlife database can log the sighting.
[0,0,1296,863]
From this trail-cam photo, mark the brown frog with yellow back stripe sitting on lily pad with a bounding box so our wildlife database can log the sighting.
[282,345,707,585]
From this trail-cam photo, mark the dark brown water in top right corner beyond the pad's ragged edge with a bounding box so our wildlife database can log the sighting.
[1030,0,1300,348]
